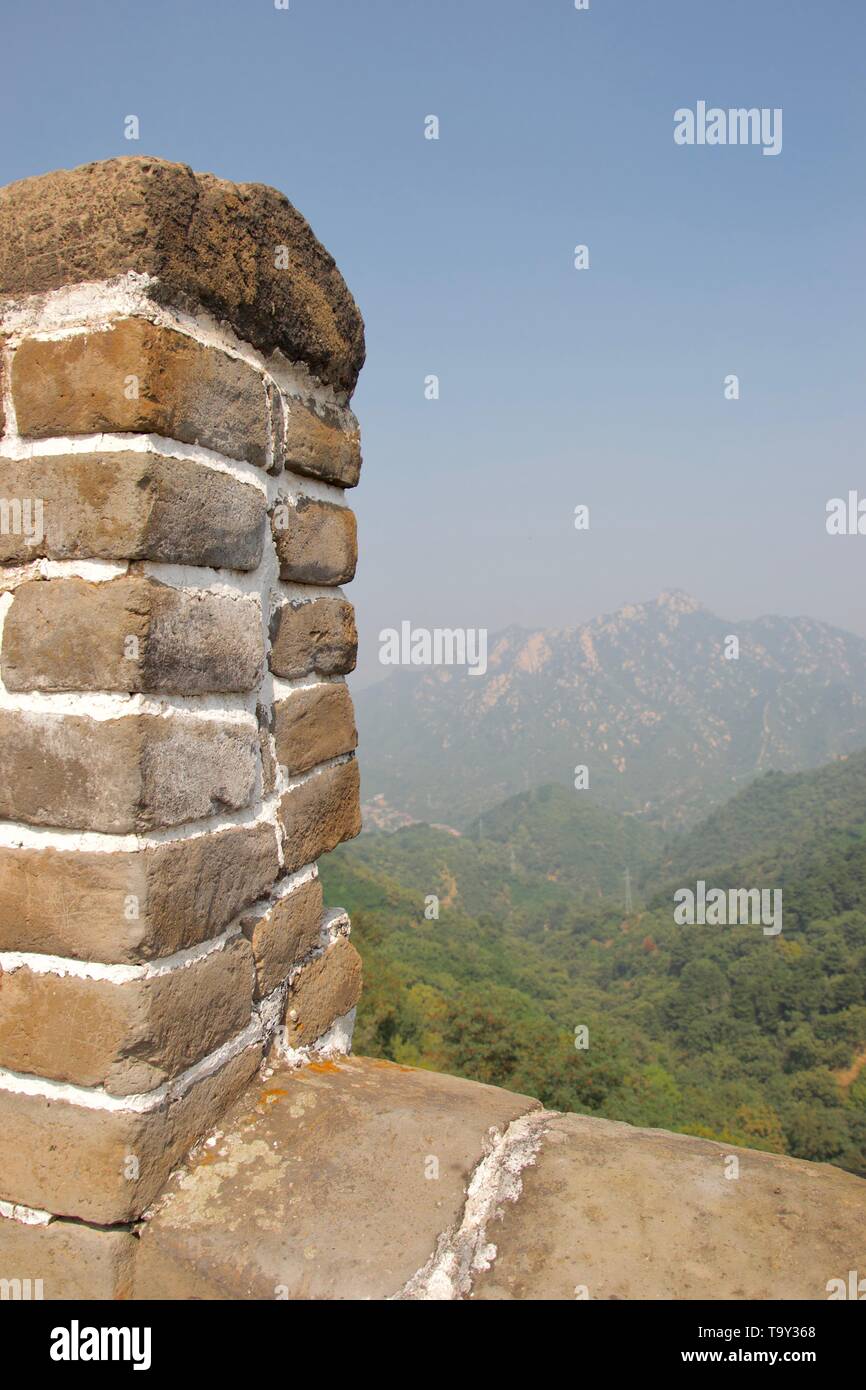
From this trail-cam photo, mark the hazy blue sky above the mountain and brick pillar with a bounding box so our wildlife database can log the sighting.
[0,0,866,676]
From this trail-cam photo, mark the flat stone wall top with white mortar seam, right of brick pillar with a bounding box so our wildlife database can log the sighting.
[135,1058,866,1300]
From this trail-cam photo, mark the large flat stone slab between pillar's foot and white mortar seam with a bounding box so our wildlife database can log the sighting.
[135,1058,542,1305]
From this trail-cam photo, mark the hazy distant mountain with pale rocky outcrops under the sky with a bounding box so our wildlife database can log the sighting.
[356,592,866,827]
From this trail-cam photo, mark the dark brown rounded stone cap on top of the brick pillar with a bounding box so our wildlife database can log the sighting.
[0,156,364,395]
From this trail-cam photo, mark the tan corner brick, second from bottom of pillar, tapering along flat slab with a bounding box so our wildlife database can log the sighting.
[0,1041,261,1226]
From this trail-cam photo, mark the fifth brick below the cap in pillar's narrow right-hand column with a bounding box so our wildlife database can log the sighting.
[279,758,361,873]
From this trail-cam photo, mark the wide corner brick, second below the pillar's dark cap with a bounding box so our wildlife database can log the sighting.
[0,452,265,570]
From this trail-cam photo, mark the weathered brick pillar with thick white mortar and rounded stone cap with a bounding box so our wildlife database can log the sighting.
[0,158,363,1298]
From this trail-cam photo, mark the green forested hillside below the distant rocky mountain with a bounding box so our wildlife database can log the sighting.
[322,758,866,1175]
